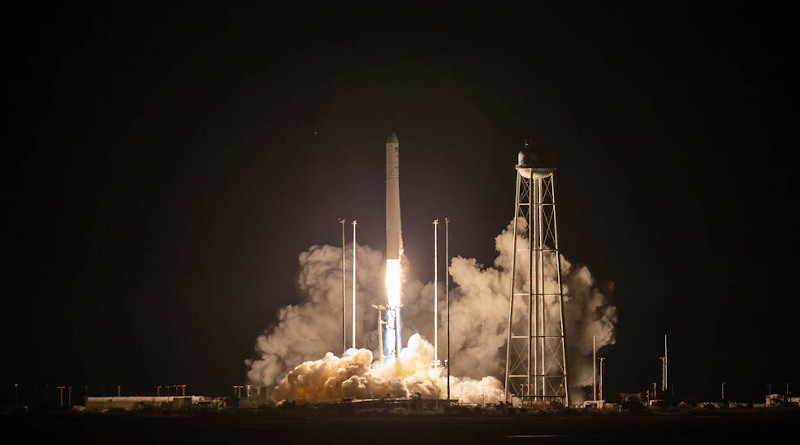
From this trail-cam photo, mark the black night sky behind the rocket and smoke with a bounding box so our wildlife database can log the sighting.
[0,2,800,400]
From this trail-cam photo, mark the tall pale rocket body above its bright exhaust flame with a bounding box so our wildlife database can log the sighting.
[386,133,403,260]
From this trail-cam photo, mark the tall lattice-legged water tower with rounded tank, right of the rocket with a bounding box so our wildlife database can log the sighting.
[505,142,569,406]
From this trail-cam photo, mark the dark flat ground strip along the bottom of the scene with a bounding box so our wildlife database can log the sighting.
[0,411,800,445]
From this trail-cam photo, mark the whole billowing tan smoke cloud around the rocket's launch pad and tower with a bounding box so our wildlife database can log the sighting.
[247,220,616,401]
